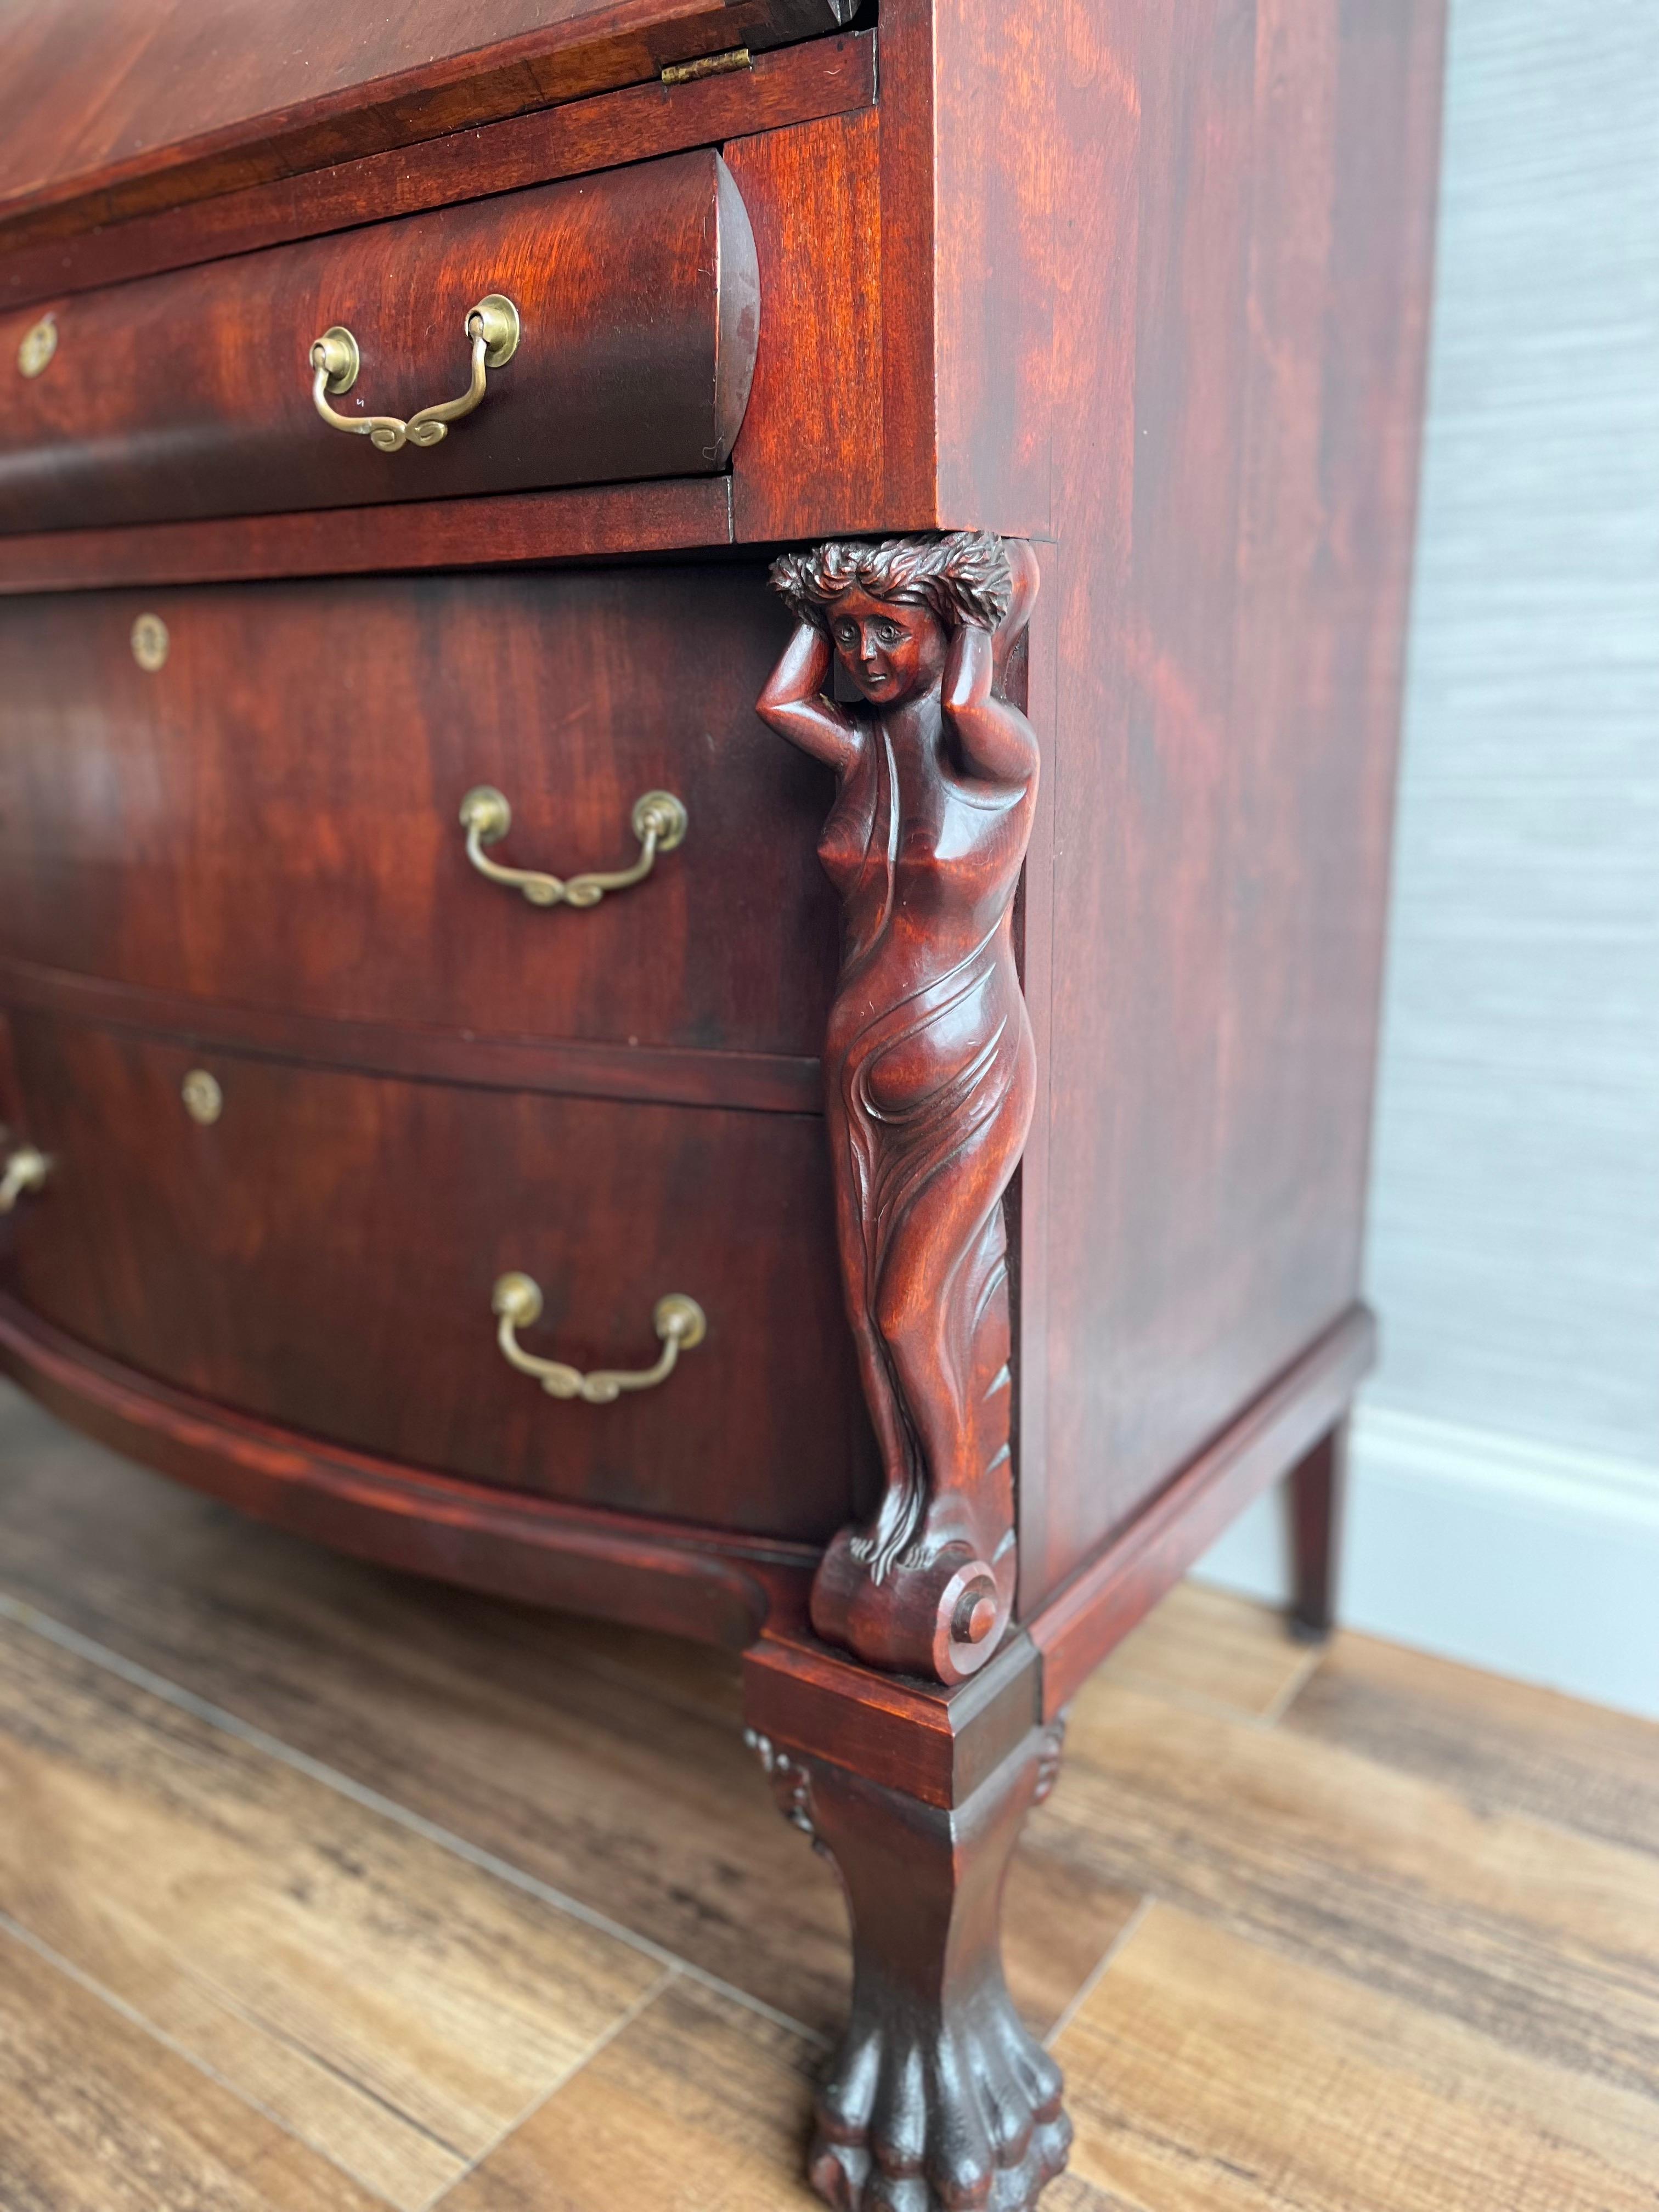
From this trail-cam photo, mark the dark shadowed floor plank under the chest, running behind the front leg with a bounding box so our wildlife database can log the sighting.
[0,1385,1135,2035]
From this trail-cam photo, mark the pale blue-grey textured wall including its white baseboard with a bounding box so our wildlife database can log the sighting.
[1205,0,1659,1714]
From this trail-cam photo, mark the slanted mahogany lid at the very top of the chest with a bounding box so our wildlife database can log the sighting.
[0,0,854,252]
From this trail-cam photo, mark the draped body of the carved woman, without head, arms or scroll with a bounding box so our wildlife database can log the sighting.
[819,695,1035,1579]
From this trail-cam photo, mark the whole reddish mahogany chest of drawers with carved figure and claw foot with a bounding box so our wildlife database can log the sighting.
[0,0,1440,2212]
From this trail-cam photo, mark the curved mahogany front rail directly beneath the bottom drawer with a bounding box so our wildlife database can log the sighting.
[0,1294,812,1650]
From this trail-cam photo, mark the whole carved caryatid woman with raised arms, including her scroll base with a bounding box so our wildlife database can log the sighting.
[759,533,1037,1681]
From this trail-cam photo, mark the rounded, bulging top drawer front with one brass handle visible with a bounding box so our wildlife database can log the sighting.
[0,150,759,531]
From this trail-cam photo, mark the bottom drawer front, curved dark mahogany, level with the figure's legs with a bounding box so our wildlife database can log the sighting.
[11,1015,874,1539]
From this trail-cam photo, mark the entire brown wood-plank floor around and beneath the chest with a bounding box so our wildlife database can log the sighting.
[0,1385,1659,2212]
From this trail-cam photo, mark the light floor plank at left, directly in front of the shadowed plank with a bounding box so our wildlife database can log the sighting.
[0,1621,662,2212]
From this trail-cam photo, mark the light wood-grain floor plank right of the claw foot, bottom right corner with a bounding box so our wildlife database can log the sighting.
[1057,1905,1659,2212]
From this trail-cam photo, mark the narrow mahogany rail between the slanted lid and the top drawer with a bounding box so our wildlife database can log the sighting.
[0,31,876,312]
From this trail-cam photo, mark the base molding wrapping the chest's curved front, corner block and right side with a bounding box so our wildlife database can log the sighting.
[0,1292,1376,1699]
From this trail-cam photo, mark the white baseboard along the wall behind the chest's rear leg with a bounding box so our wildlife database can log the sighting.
[1197,1407,1659,1719]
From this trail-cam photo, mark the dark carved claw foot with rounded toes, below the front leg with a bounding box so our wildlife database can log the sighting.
[808,1978,1070,2212]
